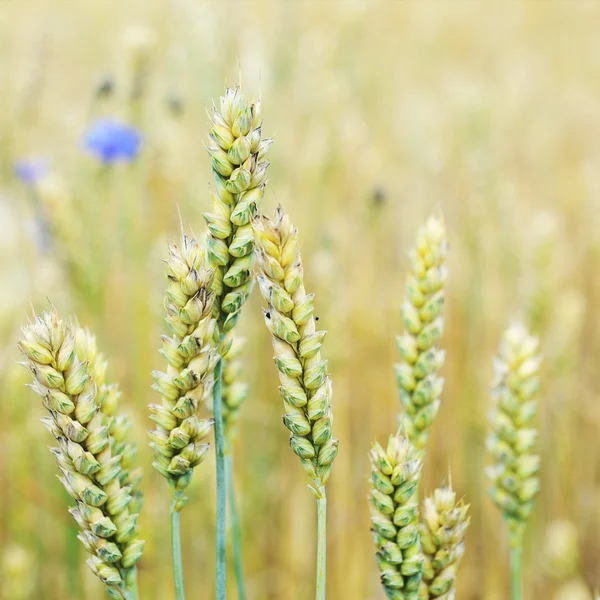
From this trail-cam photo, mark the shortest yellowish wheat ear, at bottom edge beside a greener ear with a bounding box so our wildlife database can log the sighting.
[419,485,470,600]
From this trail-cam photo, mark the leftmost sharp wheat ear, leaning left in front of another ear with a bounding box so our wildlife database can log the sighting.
[19,312,144,598]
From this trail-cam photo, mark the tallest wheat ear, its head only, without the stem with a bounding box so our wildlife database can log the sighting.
[204,87,272,334]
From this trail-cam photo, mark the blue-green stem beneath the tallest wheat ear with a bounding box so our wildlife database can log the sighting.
[213,359,227,600]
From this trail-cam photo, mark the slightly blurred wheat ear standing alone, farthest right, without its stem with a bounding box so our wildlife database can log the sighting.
[487,324,541,548]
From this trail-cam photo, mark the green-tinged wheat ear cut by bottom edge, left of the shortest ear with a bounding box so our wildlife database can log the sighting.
[370,434,423,600]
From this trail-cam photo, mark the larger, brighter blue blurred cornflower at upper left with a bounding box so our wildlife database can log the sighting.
[83,119,142,165]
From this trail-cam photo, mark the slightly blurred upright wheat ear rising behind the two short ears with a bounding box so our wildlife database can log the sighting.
[395,215,448,450]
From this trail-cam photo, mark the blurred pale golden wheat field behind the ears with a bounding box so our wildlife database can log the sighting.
[0,0,600,600]
